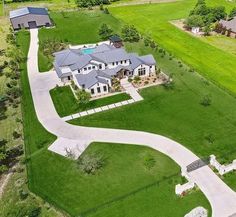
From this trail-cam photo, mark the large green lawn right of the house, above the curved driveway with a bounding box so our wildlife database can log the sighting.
[71,40,236,162]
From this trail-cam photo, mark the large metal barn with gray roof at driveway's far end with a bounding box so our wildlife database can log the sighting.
[10,7,52,30]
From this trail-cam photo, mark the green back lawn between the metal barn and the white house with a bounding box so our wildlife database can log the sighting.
[39,10,121,72]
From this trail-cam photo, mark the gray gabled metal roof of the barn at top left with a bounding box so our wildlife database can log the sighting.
[10,7,48,19]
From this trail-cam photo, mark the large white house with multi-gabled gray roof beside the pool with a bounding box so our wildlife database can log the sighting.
[53,44,156,96]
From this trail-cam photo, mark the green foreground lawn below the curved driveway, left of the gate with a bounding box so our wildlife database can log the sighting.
[30,143,211,217]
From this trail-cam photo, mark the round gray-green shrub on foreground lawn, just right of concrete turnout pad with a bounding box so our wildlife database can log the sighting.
[77,153,105,174]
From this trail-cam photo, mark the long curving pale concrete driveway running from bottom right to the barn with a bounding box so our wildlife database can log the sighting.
[27,29,236,217]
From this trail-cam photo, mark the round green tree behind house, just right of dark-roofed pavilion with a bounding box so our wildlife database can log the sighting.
[121,25,140,42]
